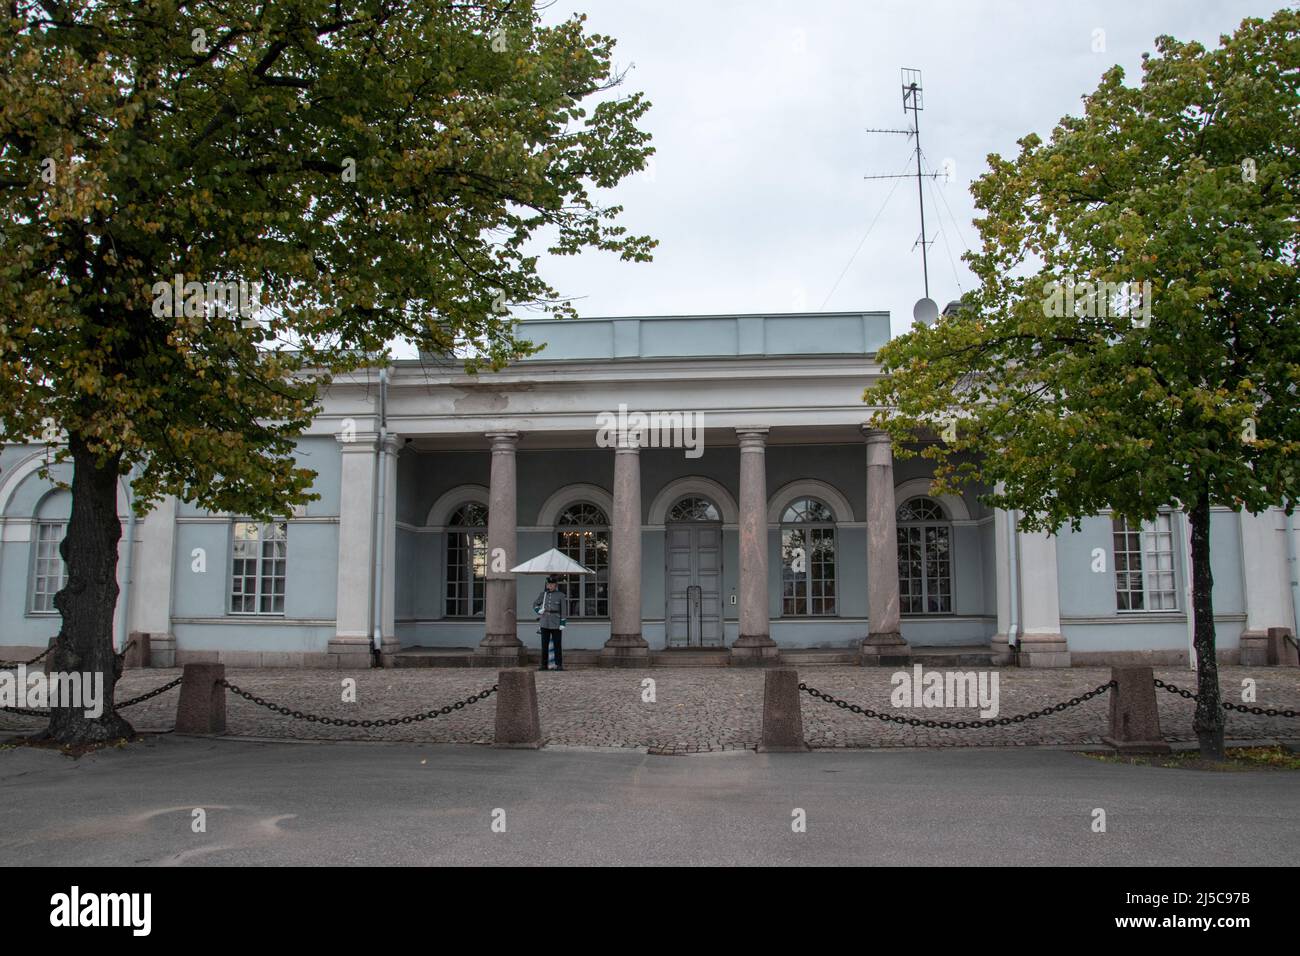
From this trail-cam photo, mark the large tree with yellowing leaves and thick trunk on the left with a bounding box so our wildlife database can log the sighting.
[0,0,654,743]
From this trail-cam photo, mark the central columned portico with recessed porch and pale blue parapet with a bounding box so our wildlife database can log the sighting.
[325,313,996,666]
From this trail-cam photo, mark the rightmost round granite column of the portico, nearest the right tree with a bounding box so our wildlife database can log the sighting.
[862,427,910,666]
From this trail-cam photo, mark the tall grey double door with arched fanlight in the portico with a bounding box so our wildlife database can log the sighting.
[664,494,723,648]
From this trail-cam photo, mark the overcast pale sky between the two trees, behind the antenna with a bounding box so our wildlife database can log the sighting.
[491,0,1283,343]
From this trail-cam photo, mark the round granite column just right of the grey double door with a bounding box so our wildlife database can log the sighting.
[731,428,780,665]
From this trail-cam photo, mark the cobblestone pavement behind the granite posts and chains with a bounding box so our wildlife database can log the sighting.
[0,666,1300,753]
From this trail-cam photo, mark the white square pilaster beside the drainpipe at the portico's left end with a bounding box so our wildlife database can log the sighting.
[328,432,378,667]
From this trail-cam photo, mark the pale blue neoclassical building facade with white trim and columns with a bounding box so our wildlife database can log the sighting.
[0,312,1295,667]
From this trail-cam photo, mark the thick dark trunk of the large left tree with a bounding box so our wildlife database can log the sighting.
[48,434,135,744]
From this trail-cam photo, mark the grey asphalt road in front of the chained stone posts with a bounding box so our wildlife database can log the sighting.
[0,737,1300,866]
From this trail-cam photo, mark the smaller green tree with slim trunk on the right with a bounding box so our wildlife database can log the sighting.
[866,10,1300,757]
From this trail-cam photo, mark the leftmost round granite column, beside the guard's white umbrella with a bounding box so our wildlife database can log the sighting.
[477,432,524,667]
